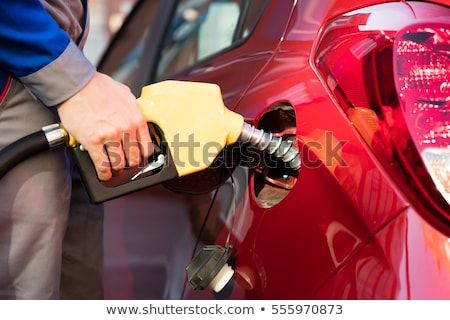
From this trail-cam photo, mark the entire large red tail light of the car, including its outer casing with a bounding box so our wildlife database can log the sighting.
[313,3,450,232]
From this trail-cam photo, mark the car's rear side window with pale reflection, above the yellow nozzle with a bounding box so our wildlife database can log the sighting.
[156,0,266,80]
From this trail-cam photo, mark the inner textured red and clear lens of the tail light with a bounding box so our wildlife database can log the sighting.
[393,20,450,203]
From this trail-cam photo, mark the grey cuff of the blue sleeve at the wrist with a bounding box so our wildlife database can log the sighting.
[20,42,96,107]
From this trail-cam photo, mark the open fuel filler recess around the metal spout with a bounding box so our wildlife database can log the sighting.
[252,103,300,208]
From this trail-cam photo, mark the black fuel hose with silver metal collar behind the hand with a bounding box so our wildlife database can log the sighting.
[0,124,66,179]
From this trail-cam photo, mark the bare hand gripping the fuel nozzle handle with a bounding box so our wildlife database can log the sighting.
[58,72,153,181]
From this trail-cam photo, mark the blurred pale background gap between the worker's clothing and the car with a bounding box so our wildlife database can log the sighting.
[85,0,136,64]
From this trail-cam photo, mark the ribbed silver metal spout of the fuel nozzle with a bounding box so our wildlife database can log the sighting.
[239,122,301,170]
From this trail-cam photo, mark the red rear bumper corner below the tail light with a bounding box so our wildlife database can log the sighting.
[314,208,450,300]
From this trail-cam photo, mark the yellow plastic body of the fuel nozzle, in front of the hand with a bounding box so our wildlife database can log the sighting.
[137,80,244,176]
